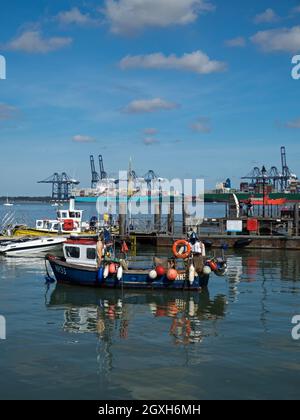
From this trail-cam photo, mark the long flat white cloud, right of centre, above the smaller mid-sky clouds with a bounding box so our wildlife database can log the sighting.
[120,50,226,74]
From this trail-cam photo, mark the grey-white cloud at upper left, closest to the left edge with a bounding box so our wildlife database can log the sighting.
[4,30,72,53]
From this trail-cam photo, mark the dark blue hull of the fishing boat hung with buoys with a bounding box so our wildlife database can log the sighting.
[46,255,209,291]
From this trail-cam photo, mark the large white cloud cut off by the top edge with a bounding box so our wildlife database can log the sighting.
[102,0,215,34]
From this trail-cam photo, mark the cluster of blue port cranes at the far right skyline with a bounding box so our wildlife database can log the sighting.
[240,146,300,194]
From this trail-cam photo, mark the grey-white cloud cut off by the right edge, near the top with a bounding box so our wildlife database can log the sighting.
[251,26,300,52]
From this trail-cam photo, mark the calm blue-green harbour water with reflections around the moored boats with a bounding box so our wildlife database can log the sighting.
[0,205,300,399]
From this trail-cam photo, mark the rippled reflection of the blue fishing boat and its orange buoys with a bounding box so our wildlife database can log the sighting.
[47,285,227,345]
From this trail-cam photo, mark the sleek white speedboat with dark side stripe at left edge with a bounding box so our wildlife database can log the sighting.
[0,237,66,256]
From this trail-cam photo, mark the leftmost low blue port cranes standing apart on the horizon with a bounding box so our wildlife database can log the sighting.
[38,172,79,201]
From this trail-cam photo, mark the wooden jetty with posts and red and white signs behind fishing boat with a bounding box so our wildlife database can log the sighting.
[117,199,300,250]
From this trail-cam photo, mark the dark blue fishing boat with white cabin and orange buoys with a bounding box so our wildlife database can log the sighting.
[46,238,226,291]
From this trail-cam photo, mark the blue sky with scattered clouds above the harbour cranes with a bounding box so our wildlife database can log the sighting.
[0,0,300,195]
